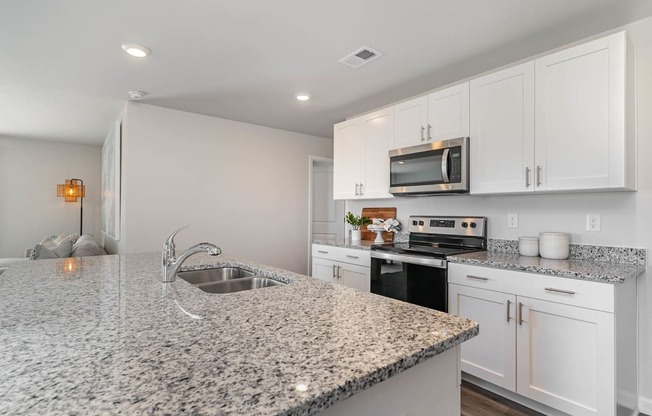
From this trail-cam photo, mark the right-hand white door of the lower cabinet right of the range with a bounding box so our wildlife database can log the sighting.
[517,297,616,416]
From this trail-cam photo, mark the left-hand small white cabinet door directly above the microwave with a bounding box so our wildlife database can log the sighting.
[392,96,428,149]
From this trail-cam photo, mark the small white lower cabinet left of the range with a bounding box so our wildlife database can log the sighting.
[312,244,371,292]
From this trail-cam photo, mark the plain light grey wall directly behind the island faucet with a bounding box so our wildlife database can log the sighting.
[109,103,333,273]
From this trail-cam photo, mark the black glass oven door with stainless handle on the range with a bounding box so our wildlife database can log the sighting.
[371,251,448,312]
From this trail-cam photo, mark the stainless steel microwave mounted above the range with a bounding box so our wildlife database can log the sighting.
[389,137,469,196]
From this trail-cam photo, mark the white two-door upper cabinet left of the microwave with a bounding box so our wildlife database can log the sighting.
[333,107,394,199]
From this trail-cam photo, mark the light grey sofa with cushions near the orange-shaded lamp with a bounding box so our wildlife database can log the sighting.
[0,234,106,274]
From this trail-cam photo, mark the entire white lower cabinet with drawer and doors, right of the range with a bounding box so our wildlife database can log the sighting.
[449,263,637,416]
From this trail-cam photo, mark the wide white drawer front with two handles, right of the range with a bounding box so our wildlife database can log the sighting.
[448,263,614,313]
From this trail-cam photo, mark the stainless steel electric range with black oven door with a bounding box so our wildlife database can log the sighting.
[371,216,487,312]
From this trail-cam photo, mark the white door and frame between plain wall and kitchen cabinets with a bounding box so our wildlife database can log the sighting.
[308,156,344,270]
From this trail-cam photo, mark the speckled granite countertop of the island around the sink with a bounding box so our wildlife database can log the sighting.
[0,253,478,415]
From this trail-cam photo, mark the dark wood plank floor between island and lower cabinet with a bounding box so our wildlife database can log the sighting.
[462,382,544,416]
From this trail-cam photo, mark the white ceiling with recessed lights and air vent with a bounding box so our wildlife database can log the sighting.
[0,0,652,144]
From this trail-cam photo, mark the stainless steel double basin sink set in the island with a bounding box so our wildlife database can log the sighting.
[177,267,285,293]
